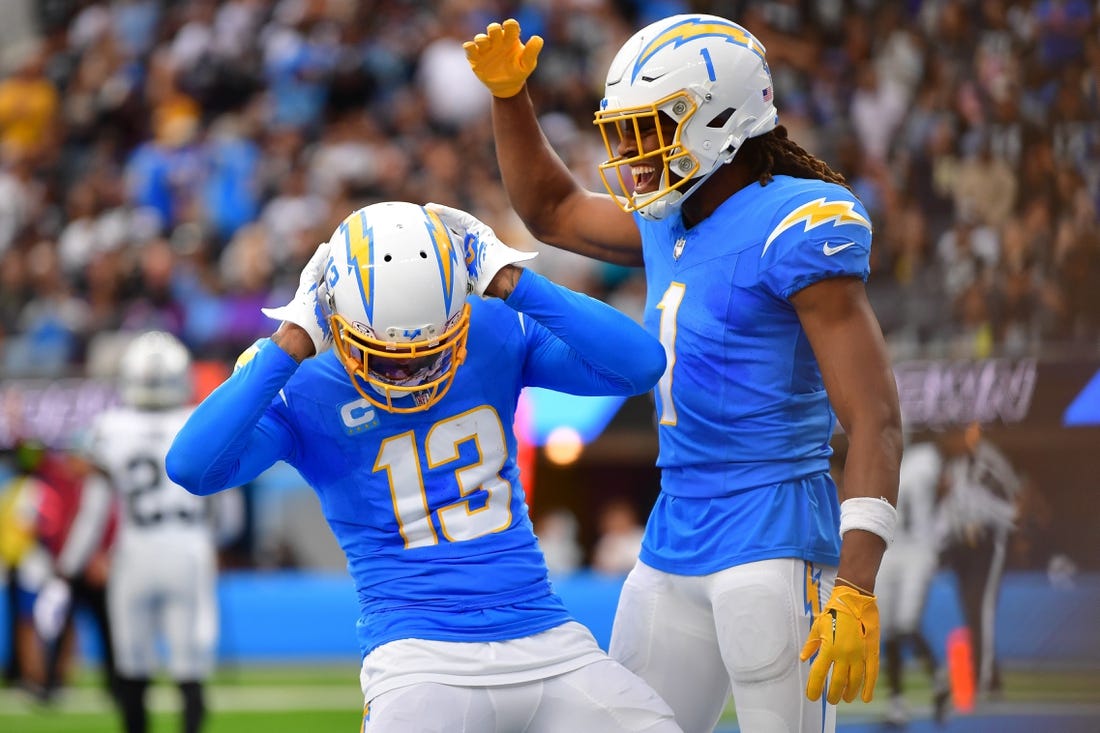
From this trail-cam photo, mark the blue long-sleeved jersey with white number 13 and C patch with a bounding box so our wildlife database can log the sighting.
[168,271,664,656]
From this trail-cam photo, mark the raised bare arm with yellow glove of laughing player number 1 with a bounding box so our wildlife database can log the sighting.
[464,20,641,265]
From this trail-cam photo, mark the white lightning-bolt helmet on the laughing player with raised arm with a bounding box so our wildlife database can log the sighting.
[595,15,779,220]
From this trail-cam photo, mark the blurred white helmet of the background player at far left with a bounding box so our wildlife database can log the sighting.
[119,331,193,409]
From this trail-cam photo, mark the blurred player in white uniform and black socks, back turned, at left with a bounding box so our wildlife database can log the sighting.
[35,331,239,733]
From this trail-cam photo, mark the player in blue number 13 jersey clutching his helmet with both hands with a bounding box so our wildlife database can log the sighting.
[168,201,680,733]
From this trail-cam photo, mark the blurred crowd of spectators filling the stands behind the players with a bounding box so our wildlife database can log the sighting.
[0,0,1100,376]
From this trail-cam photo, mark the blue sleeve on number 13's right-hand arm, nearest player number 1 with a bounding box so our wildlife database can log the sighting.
[505,270,664,395]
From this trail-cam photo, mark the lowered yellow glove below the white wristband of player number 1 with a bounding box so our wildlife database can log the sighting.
[800,586,879,705]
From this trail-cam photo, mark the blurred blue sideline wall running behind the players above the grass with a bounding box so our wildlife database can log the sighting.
[0,571,1100,669]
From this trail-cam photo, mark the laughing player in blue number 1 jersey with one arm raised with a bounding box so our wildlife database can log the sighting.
[465,14,902,733]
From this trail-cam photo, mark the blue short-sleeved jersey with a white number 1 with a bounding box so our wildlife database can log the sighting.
[635,176,871,575]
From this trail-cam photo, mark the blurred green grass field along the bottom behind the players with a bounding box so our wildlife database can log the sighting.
[0,666,1100,733]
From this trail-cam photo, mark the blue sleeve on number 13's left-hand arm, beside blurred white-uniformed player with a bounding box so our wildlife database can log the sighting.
[165,340,298,495]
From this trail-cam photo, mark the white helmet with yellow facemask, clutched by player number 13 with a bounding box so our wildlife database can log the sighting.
[326,201,470,413]
